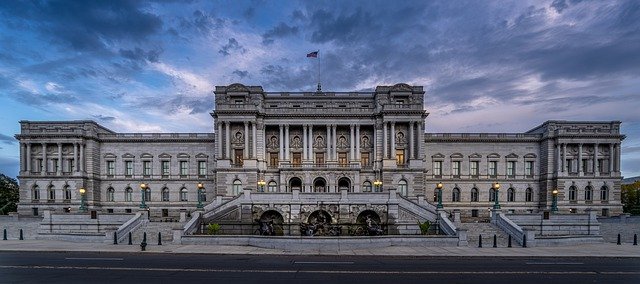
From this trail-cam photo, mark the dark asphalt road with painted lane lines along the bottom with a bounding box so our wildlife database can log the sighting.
[0,252,640,284]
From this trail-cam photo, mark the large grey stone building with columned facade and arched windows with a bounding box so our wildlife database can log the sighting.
[16,84,624,221]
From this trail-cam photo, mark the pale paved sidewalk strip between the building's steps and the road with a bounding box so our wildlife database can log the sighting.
[0,240,640,257]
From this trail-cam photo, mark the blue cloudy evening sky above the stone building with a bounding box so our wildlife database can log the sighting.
[0,0,640,177]
